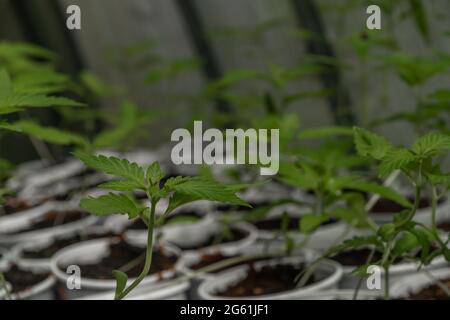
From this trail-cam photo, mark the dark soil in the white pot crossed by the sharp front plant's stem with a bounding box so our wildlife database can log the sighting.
[73,241,177,280]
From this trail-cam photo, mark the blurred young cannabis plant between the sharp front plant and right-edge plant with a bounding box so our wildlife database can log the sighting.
[279,127,409,238]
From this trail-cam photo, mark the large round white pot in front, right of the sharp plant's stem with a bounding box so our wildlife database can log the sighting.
[198,257,343,300]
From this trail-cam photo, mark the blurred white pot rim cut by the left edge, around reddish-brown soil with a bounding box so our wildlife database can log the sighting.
[0,202,98,246]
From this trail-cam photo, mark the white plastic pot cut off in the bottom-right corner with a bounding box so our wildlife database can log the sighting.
[390,268,450,299]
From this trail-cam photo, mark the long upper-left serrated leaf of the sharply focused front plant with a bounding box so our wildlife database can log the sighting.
[74,152,146,189]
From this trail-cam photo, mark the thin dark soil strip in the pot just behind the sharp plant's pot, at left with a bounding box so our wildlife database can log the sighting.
[20,233,114,259]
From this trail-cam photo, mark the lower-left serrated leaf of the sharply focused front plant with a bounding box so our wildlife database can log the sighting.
[80,193,144,219]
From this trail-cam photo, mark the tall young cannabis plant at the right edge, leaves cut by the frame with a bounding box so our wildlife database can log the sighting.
[338,128,450,299]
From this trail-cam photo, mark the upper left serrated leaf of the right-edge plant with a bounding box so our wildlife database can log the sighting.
[353,127,392,160]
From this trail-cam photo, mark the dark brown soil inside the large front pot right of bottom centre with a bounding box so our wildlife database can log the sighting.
[217,264,315,298]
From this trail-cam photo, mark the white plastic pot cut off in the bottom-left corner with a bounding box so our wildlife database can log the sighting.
[0,268,56,300]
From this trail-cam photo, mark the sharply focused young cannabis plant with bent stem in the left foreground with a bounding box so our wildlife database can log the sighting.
[75,152,249,300]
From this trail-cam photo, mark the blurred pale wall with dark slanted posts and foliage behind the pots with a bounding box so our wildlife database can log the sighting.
[0,0,450,163]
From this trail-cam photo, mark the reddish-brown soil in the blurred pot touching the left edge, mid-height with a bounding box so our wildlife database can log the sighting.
[5,211,88,234]
